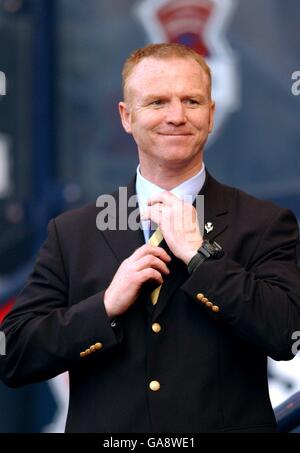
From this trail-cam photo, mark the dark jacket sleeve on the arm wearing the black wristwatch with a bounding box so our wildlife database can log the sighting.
[182,210,300,360]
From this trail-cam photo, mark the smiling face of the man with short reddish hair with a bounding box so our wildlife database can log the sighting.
[119,57,214,168]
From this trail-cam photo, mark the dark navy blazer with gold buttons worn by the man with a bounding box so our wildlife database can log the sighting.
[0,174,300,433]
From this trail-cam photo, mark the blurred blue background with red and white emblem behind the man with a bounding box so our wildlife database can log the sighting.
[0,0,300,432]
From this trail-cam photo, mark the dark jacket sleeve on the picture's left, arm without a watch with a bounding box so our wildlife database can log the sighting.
[0,220,122,387]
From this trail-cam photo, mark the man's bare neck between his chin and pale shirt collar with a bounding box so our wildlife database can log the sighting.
[140,159,203,190]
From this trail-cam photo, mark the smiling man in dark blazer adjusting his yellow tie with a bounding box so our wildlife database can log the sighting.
[2,44,300,433]
